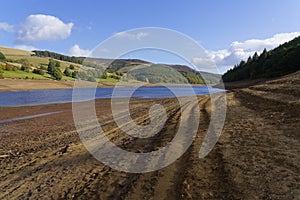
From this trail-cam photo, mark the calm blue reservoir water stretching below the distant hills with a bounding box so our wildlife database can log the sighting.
[0,86,224,106]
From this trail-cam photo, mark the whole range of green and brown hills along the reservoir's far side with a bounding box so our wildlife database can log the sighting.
[0,47,221,84]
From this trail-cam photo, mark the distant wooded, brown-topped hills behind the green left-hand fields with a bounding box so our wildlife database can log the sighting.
[34,51,221,84]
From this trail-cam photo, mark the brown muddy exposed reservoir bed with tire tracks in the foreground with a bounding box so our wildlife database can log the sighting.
[0,73,300,200]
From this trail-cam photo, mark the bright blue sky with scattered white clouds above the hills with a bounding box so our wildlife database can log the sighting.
[0,0,300,73]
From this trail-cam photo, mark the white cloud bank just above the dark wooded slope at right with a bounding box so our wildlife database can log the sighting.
[199,32,300,73]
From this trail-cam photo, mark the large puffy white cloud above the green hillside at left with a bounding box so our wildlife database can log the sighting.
[17,14,74,42]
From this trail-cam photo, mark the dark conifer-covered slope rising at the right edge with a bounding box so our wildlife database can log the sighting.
[222,36,300,82]
